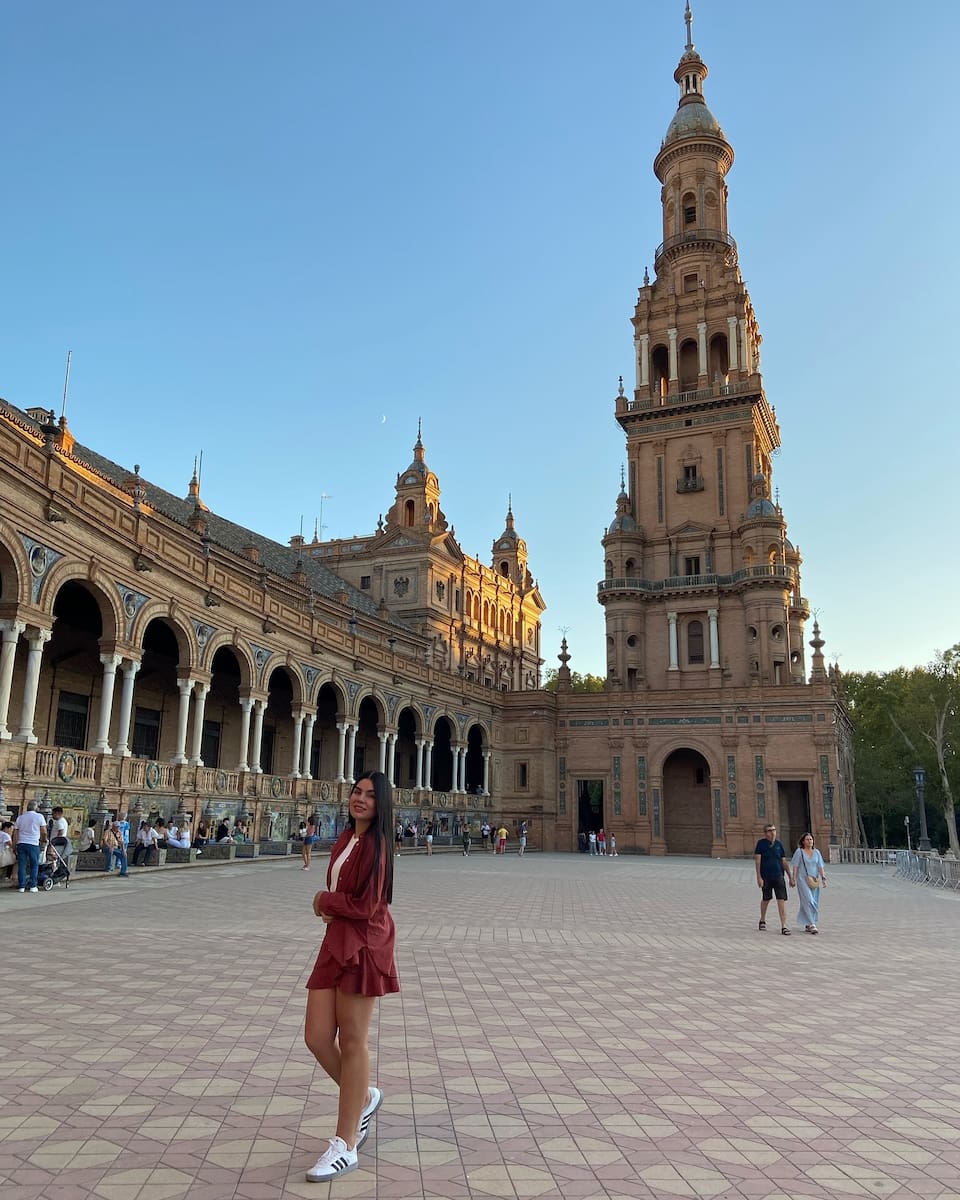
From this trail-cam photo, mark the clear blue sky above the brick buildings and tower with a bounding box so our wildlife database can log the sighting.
[0,0,960,673]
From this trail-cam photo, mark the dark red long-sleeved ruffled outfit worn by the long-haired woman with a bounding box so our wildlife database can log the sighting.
[307,827,400,996]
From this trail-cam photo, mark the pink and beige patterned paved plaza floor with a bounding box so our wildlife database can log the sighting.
[0,851,960,1200]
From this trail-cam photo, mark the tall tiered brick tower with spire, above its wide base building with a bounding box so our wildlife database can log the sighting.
[599,0,809,690]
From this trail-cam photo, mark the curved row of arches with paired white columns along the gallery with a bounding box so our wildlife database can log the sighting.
[0,568,490,791]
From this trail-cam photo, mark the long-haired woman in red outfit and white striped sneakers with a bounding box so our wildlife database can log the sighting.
[304,770,400,1183]
